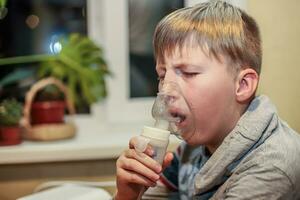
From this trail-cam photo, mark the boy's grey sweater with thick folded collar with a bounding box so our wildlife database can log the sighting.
[143,96,300,200]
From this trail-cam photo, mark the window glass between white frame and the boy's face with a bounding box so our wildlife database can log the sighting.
[128,0,184,98]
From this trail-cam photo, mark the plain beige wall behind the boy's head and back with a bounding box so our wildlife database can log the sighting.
[247,0,300,132]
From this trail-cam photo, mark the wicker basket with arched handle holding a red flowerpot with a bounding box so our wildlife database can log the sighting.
[21,77,76,141]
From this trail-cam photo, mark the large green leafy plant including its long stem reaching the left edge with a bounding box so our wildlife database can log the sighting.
[0,33,110,112]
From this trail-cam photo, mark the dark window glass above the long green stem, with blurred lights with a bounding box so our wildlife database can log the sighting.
[0,0,87,57]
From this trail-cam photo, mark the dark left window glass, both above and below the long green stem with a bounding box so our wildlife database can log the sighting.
[0,0,87,104]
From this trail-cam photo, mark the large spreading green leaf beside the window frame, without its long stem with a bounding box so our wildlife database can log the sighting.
[39,33,110,108]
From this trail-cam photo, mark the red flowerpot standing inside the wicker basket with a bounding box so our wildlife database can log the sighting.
[31,101,65,124]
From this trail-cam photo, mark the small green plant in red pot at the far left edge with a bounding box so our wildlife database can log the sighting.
[0,99,23,145]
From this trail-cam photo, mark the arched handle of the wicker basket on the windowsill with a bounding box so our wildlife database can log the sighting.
[21,77,75,128]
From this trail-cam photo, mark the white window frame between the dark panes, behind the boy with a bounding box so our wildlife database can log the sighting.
[87,0,247,123]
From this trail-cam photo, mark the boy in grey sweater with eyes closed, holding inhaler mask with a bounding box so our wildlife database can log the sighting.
[115,1,300,200]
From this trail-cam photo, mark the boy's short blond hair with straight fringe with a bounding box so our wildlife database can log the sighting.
[153,0,262,74]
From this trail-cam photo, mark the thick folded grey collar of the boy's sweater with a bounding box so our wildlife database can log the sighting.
[195,95,278,193]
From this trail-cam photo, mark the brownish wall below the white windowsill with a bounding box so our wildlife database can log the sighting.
[0,159,116,200]
